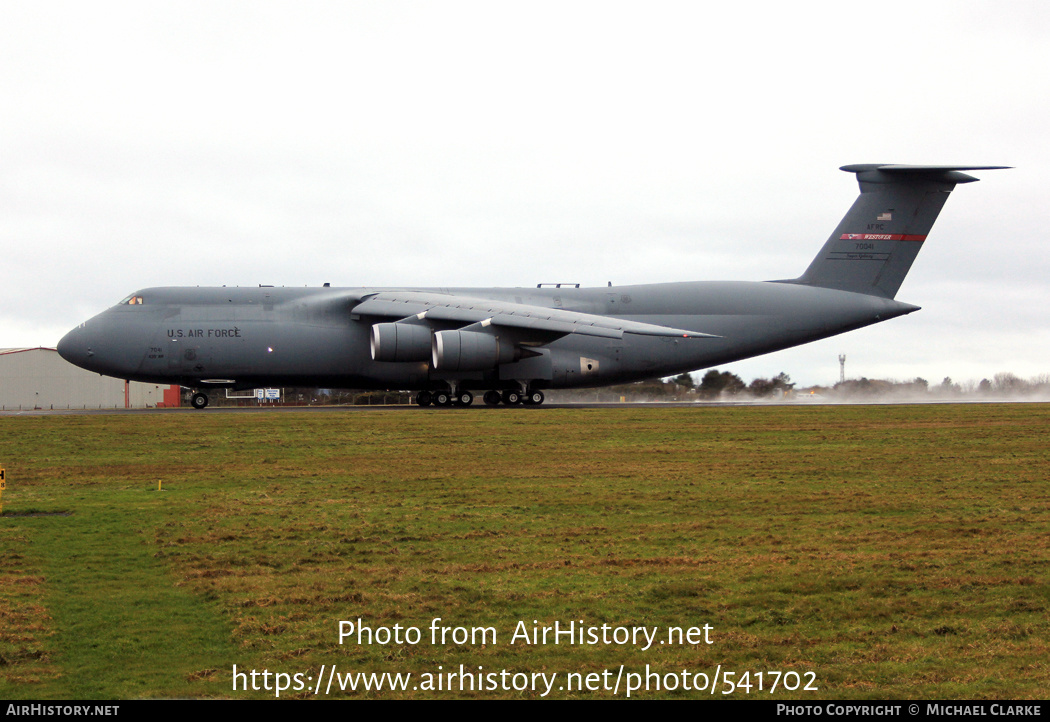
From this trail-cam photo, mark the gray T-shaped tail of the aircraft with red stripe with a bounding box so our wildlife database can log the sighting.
[789,164,1006,298]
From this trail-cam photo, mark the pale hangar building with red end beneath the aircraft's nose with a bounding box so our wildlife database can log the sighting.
[0,348,180,411]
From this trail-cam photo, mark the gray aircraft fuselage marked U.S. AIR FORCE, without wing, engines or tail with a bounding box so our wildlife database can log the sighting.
[58,281,918,389]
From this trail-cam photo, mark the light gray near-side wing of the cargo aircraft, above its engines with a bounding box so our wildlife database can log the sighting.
[352,291,718,339]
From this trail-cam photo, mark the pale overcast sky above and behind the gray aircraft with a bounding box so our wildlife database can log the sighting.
[0,0,1050,384]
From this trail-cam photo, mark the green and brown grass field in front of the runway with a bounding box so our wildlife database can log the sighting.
[0,404,1050,700]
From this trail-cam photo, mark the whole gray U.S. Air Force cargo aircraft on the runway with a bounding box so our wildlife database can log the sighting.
[58,164,1005,408]
